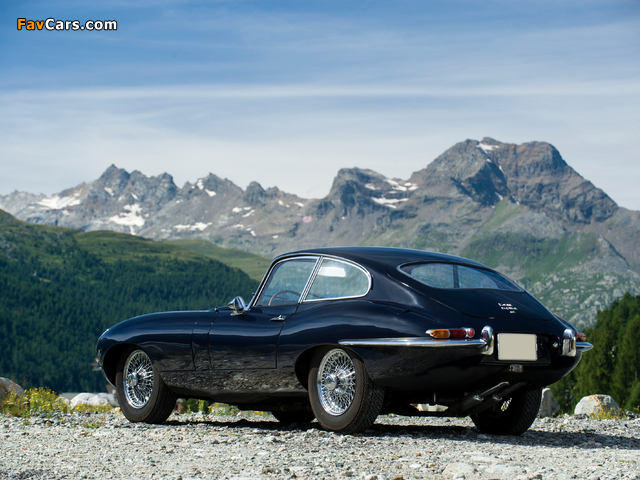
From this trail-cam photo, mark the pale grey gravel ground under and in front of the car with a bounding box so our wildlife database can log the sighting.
[0,412,640,480]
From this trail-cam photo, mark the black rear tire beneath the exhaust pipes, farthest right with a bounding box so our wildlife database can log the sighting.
[471,388,542,435]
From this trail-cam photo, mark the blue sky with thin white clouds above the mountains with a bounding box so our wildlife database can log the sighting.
[0,0,640,210]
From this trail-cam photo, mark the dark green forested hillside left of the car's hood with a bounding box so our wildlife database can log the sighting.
[0,211,257,391]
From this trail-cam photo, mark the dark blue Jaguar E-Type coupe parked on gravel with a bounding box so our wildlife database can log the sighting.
[97,247,591,435]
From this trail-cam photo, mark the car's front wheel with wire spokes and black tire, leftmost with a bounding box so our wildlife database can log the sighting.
[116,349,178,423]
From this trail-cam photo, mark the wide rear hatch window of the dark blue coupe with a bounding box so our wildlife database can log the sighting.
[400,263,522,292]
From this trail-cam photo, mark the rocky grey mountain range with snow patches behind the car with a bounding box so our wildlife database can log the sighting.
[0,138,640,328]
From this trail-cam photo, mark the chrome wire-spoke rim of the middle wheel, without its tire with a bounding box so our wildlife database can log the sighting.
[317,348,356,416]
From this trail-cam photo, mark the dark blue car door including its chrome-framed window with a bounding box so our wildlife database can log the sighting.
[209,257,318,370]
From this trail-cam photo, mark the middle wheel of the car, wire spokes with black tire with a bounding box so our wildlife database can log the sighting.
[309,347,384,433]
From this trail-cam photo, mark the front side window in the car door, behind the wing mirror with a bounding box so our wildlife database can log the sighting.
[256,258,318,306]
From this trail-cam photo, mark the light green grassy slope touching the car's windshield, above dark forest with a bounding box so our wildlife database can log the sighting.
[165,239,271,281]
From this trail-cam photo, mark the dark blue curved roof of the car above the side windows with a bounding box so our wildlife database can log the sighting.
[274,247,488,268]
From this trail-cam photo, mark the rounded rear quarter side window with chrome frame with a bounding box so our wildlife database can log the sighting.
[305,258,369,300]
